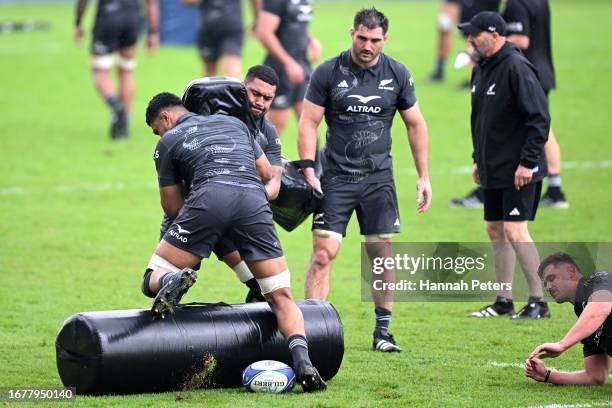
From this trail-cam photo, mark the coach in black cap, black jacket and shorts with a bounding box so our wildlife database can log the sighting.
[458,11,550,319]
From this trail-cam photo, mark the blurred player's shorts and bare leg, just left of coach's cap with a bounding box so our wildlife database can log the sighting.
[429,0,501,82]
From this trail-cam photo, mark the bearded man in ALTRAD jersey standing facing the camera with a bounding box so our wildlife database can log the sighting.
[298,8,432,352]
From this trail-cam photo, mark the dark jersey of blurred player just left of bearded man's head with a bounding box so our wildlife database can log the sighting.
[262,0,312,61]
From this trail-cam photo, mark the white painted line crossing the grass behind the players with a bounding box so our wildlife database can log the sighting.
[0,160,612,196]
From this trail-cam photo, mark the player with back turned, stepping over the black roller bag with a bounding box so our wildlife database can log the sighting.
[145,92,326,392]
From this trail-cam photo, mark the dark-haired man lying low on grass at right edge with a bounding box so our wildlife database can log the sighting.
[525,253,612,385]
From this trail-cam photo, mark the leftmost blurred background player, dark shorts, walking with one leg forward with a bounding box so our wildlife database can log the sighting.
[74,0,159,139]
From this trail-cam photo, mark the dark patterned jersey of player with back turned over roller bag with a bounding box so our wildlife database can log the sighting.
[153,113,263,191]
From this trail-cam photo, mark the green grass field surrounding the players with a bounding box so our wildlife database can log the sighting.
[0,0,612,407]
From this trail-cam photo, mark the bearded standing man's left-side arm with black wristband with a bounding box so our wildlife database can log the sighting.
[298,99,325,192]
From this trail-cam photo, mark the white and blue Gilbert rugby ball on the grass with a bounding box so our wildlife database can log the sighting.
[242,360,295,394]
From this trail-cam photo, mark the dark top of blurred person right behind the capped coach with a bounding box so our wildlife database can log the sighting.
[503,0,555,91]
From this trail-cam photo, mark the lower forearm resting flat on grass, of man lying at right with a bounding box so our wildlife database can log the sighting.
[525,353,610,385]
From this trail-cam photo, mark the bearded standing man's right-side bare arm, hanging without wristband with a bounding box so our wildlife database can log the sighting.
[400,103,432,212]
